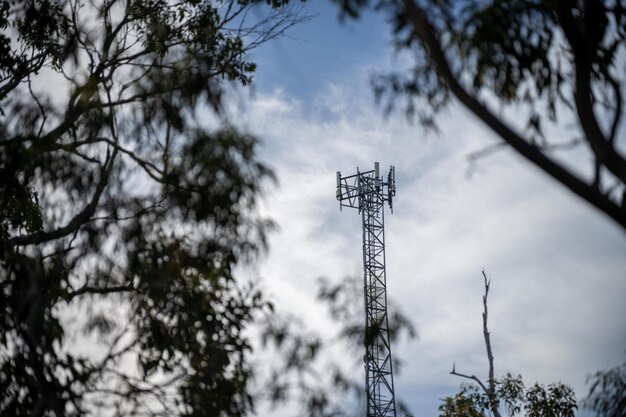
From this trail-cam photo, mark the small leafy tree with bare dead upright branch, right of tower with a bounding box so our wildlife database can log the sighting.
[439,271,578,417]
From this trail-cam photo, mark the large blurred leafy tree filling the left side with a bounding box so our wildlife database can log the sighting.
[0,0,302,416]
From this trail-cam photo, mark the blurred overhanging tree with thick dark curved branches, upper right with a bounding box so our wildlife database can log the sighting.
[335,0,626,230]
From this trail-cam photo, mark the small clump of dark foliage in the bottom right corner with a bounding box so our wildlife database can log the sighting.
[583,363,626,417]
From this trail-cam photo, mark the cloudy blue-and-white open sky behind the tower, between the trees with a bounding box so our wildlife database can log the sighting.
[223,2,626,417]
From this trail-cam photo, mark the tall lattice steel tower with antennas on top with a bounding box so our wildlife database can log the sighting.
[337,162,396,417]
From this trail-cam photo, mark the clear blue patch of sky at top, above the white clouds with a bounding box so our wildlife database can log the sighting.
[251,1,389,100]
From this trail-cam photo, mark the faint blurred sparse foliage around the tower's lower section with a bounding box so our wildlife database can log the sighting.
[261,277,416,417]
